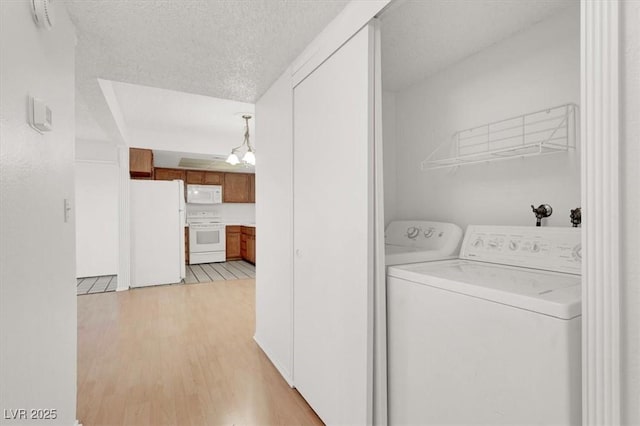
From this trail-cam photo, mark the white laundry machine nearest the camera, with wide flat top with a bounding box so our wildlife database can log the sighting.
[387,226,581,425]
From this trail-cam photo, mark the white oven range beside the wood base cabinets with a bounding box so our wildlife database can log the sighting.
[187,212,227,265]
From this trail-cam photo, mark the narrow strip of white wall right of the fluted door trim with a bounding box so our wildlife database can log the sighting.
[620,0,640,425]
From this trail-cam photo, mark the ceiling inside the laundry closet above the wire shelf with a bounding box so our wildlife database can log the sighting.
[382,0,579,91]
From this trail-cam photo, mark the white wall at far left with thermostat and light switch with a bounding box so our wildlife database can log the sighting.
[0,1,77,426]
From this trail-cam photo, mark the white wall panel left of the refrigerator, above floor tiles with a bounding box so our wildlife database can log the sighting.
[76,161,118,277]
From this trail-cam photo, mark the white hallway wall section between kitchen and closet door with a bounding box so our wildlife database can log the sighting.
[255,72,293,384]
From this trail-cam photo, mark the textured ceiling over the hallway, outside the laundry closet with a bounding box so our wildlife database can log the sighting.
[65,0,348,142]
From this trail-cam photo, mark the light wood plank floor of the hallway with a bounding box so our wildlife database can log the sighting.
[77,279,322,426]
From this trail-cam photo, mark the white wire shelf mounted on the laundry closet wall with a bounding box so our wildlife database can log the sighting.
[422,104,578,170]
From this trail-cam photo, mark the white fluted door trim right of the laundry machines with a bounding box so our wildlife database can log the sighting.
[580,0,621,425]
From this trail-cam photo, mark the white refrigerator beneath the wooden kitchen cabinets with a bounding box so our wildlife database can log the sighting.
[129,180,185,287]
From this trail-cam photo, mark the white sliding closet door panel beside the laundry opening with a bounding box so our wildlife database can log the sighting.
[293,26,374,425]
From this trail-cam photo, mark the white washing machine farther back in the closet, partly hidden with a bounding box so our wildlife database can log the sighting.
[384,220,462,266]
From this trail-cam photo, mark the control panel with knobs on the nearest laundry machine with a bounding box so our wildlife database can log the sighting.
[460,225,582,274]
